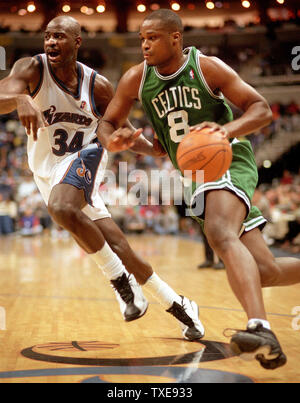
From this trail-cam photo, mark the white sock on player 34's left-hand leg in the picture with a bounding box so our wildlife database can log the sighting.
[89,242,127,280]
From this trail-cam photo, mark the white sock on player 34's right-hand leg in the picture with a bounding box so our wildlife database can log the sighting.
[143,273,181,309]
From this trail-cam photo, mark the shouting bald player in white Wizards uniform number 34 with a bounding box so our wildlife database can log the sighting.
[0,16,204,340]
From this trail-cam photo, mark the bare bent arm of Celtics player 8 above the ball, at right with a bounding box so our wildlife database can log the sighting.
[200,56,272,137]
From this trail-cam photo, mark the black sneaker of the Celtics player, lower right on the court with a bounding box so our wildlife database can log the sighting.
[230,323,287,369]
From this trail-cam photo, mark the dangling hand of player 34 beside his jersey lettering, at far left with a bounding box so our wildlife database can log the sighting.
[17,95,48,141]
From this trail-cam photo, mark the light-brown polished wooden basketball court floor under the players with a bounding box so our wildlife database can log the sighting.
[0,235,300,383]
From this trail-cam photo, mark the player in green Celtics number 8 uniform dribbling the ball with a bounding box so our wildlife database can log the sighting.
[98,9,300,369]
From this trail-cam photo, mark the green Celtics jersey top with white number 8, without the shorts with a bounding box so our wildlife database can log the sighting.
[139,47,233,168]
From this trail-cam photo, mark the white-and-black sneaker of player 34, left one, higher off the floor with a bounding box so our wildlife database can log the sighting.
[111,273,149,322]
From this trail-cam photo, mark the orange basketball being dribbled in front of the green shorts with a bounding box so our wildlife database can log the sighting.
[177,128,232,182]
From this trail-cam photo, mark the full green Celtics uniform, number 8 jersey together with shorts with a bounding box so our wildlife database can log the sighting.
[139,47,266,234]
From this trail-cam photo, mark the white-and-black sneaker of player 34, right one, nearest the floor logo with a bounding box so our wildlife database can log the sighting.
[167,296,205,341]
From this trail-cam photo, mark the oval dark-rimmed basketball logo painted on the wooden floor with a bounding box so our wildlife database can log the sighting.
[21,339,234,367]
